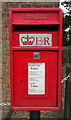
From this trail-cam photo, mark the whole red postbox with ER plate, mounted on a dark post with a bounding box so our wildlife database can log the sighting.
[9,8,62,110]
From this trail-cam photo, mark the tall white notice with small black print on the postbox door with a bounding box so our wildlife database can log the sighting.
[28,63,45,95]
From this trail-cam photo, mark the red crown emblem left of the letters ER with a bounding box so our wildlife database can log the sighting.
[21,35,35,45]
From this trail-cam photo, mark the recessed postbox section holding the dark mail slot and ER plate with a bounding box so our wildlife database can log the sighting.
[13,25,59,47]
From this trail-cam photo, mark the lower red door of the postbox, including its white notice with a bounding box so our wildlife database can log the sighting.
[13,51,57,107]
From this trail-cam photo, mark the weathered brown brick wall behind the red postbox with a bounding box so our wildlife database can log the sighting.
[0,1,63,119]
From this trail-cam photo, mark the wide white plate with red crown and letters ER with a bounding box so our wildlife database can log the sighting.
[19,34,52,46]
